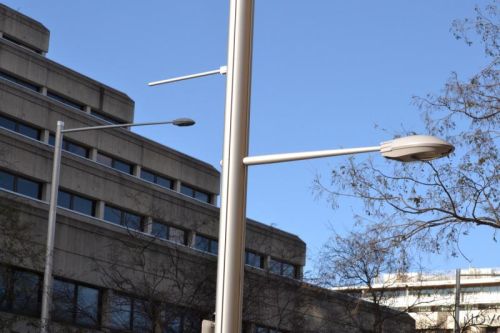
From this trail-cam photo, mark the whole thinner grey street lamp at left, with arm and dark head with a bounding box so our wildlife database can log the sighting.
[40,118,195,333]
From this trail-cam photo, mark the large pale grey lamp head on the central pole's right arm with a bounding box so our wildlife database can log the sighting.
[380,135,455,162]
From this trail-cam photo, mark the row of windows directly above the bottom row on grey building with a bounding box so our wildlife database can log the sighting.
[0,170,297,278]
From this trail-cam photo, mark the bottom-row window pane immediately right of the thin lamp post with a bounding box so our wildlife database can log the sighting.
[52,280,75,323]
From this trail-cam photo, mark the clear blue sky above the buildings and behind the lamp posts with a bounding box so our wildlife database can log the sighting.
[2,0,500,270]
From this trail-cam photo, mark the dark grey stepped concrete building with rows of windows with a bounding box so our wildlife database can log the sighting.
[0,5,414,333]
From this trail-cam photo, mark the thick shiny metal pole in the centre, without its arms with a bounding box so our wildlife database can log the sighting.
[215,0,254,333]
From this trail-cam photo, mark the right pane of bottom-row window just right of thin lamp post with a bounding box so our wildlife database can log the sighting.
[76,286,99,326]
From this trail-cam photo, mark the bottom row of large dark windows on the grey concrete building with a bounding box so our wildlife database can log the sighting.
[0,266,290,333]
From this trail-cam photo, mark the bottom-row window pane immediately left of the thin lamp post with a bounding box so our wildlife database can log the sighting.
[12,271,40,315]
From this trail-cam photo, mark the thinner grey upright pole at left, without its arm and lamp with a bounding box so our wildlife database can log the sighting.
[40,121,64,333]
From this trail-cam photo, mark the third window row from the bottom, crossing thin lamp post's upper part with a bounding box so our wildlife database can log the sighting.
[0,115,211,203]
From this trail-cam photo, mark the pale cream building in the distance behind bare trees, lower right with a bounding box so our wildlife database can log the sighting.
[339,268,500,333]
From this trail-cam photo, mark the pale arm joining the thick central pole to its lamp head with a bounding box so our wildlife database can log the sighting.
[243,146,380,165]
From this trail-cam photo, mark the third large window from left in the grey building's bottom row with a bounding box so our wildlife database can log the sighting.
[110,294,152,332]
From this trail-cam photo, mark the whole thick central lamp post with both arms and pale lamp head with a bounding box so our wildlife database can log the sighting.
[149,0,453,333]
